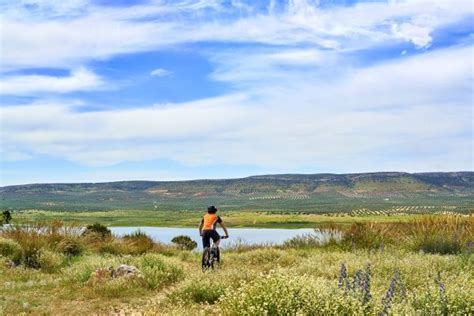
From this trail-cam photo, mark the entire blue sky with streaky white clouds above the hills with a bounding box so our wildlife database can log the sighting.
[0,0,474,185]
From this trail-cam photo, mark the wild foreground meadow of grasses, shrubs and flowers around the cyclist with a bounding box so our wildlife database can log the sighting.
[0,215,474,315]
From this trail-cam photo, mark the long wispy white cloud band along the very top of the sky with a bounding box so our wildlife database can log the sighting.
[1,0,474,70]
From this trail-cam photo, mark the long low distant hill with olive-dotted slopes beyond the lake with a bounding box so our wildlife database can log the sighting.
[0,172,474,211]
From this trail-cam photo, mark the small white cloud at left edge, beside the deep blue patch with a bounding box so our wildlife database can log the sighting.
[0,68,105,95]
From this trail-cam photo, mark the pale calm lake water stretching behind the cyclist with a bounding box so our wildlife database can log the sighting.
[109,227,326,248]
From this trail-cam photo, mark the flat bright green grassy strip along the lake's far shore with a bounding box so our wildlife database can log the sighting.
[14,210,434,228]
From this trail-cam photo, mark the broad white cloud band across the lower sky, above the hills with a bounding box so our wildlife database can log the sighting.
[1,47,473,171]
